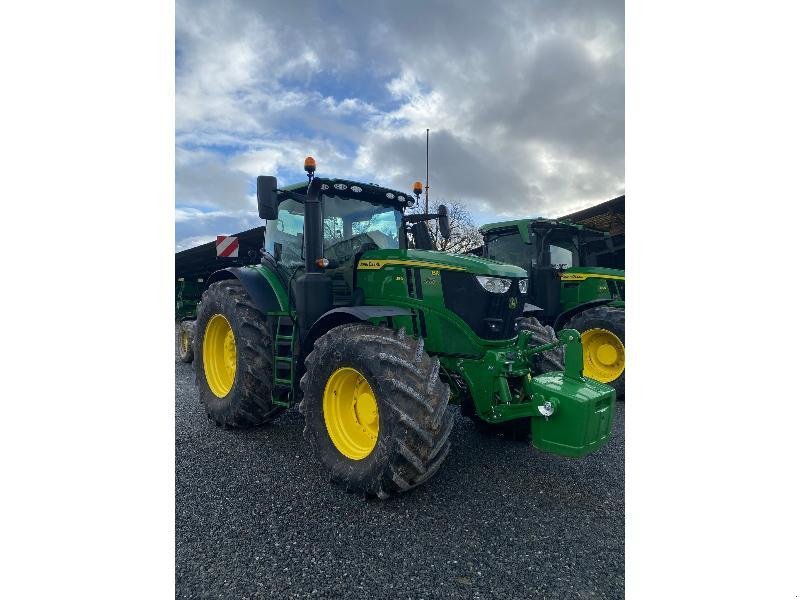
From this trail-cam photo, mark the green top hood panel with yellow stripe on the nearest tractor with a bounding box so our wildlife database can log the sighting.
[358,250,527,278]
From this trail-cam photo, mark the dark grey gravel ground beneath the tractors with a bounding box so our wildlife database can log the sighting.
[175,350,625,599]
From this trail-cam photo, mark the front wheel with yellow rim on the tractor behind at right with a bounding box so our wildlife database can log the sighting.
[564,306,625,399]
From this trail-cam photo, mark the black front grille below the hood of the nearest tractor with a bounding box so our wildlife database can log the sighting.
[442,270,524,340]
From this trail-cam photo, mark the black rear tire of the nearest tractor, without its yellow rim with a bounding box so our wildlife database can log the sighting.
[194,279,284,428]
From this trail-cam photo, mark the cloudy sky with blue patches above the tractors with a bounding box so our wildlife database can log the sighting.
[175,0,625,250]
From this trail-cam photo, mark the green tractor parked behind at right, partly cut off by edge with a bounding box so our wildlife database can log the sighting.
[480,218,625,399]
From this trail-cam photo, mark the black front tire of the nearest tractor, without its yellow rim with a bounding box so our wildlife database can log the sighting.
[300,323,453,499]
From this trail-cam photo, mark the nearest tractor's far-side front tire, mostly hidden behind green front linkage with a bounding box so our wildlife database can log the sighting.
[461,317,564,440]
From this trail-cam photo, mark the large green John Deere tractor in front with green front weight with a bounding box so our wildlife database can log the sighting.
[194,157,615,498]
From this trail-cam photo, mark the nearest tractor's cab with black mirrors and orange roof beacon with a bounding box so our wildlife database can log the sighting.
[257,162,450,338]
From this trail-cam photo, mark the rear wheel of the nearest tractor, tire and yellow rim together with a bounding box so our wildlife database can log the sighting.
[194,279,284,428]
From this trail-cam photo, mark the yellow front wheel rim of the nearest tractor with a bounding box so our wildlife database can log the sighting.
[322,367,380,460]
